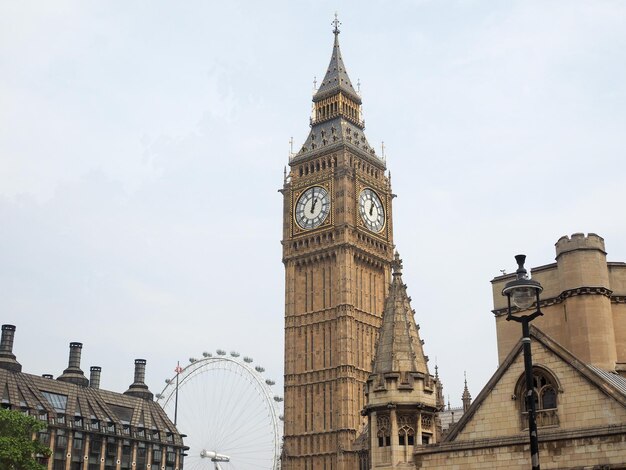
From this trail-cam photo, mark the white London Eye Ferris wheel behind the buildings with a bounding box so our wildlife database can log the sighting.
[156,349,282,470]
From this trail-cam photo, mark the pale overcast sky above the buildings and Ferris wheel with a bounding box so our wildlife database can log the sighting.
[0,0,626,414]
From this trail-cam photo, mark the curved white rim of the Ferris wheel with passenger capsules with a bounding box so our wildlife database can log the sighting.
[156,351,282,470]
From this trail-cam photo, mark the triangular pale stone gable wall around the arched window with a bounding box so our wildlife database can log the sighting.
[447,328,626,441]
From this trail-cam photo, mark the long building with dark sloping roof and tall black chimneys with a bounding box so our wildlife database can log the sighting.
[0,325,186,470]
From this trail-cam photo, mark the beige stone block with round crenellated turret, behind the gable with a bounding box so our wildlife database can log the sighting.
[491,233,626,376]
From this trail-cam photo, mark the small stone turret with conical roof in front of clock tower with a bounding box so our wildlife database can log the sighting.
[364,253,436,468]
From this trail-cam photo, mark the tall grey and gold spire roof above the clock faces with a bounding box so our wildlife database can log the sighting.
[290,15,385,165]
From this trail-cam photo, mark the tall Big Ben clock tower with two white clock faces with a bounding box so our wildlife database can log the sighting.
[282,18,393,470]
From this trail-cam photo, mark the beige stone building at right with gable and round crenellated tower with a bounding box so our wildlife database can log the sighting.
[414,233,626,470]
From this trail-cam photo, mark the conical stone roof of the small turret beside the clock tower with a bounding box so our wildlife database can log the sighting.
[373,252,428,374]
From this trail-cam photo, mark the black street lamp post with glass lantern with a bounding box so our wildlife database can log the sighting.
[502,255,543,470]
